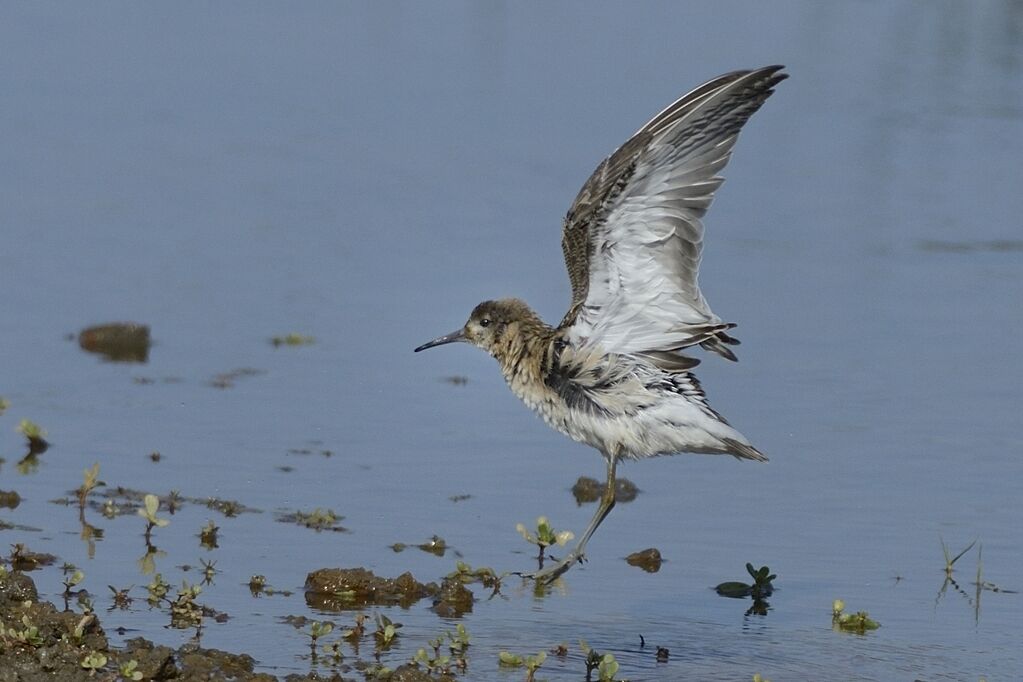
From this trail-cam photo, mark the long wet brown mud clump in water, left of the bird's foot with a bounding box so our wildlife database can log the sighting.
[305,569,438,610]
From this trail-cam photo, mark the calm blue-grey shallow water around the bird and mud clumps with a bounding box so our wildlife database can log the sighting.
[0,2,1023,680]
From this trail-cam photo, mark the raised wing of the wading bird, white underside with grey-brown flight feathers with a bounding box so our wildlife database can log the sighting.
[559,66,787,366]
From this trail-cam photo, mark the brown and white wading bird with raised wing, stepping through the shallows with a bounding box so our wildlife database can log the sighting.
[415,66,787,582]
